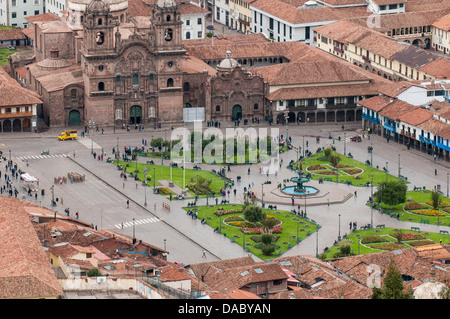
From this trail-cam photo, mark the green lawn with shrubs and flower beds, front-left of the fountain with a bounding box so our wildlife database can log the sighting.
[184,204,320,260]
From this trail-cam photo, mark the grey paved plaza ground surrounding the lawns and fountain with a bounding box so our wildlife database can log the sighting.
[0,123,450,264]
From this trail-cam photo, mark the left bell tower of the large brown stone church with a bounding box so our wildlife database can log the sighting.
[82,0,119,55]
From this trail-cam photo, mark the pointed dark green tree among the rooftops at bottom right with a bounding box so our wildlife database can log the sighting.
[372,260,413,299]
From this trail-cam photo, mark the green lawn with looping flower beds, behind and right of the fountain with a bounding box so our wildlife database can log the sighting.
[294,151,406,188]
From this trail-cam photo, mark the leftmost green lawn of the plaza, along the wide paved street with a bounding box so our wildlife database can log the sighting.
[114,161,229,197]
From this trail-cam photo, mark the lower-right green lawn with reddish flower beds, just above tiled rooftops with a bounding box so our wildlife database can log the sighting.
[322,228,450,259]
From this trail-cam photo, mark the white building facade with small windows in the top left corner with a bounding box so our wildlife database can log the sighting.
[0,0,44,28]
